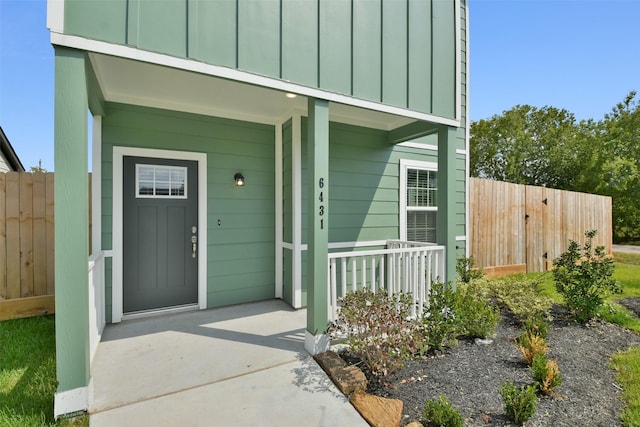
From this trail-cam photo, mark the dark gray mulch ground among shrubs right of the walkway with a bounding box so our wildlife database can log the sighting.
[340,300,640,427]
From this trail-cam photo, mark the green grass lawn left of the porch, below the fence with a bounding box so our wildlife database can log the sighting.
[0,316,88,427]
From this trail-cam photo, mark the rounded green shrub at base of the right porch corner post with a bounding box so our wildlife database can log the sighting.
[455,282,500,338]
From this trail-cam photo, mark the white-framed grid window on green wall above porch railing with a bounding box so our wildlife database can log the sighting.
[400,162,438,243]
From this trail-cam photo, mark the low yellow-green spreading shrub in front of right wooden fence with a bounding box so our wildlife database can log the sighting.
[472,274,553,322]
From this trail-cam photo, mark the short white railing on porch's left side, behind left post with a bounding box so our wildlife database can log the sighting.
[89,251,108,360]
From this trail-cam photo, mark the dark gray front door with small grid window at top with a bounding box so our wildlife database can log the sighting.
[123,156,198,313]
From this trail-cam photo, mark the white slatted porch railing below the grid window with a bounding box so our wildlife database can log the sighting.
[328,240,445,321]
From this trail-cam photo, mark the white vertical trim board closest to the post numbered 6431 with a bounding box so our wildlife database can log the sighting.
[291,115,302,308]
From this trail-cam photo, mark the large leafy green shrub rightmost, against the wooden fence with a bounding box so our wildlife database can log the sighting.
[553,230,621,323]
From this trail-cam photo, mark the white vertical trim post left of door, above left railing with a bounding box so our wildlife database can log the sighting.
[91,116,102,254]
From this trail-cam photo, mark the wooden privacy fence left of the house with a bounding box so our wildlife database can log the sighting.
[0,172,91,320]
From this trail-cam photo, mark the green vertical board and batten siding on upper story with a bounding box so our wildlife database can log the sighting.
[64,0,464,119]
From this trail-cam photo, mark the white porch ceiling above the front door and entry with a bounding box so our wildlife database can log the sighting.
[89,53,415,131]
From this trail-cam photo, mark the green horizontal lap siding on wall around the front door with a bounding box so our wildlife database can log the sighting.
[102,104,275,320]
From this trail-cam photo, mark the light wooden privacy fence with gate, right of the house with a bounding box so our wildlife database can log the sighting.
[469,178,613,276]
